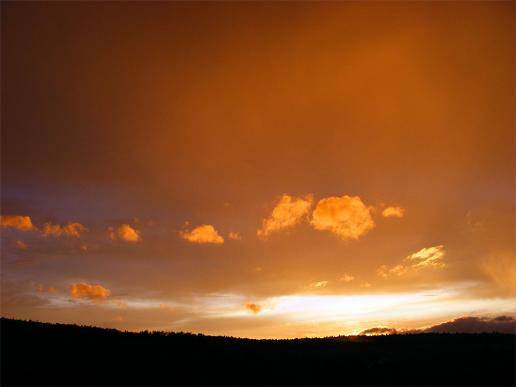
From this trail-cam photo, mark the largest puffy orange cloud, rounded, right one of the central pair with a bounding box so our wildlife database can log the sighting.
[310,195,375,240]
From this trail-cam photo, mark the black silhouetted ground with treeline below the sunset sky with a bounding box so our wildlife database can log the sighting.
[1,319,516,386]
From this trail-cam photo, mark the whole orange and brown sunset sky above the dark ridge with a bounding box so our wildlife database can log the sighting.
[0,1,516,338]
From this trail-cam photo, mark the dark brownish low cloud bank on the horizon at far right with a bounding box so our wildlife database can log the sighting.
[424,316,516,334]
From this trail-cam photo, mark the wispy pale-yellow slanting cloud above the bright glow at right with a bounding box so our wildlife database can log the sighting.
[377,245,446,278]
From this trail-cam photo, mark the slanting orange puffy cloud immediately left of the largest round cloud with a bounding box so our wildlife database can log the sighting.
[256,194,313,238]
